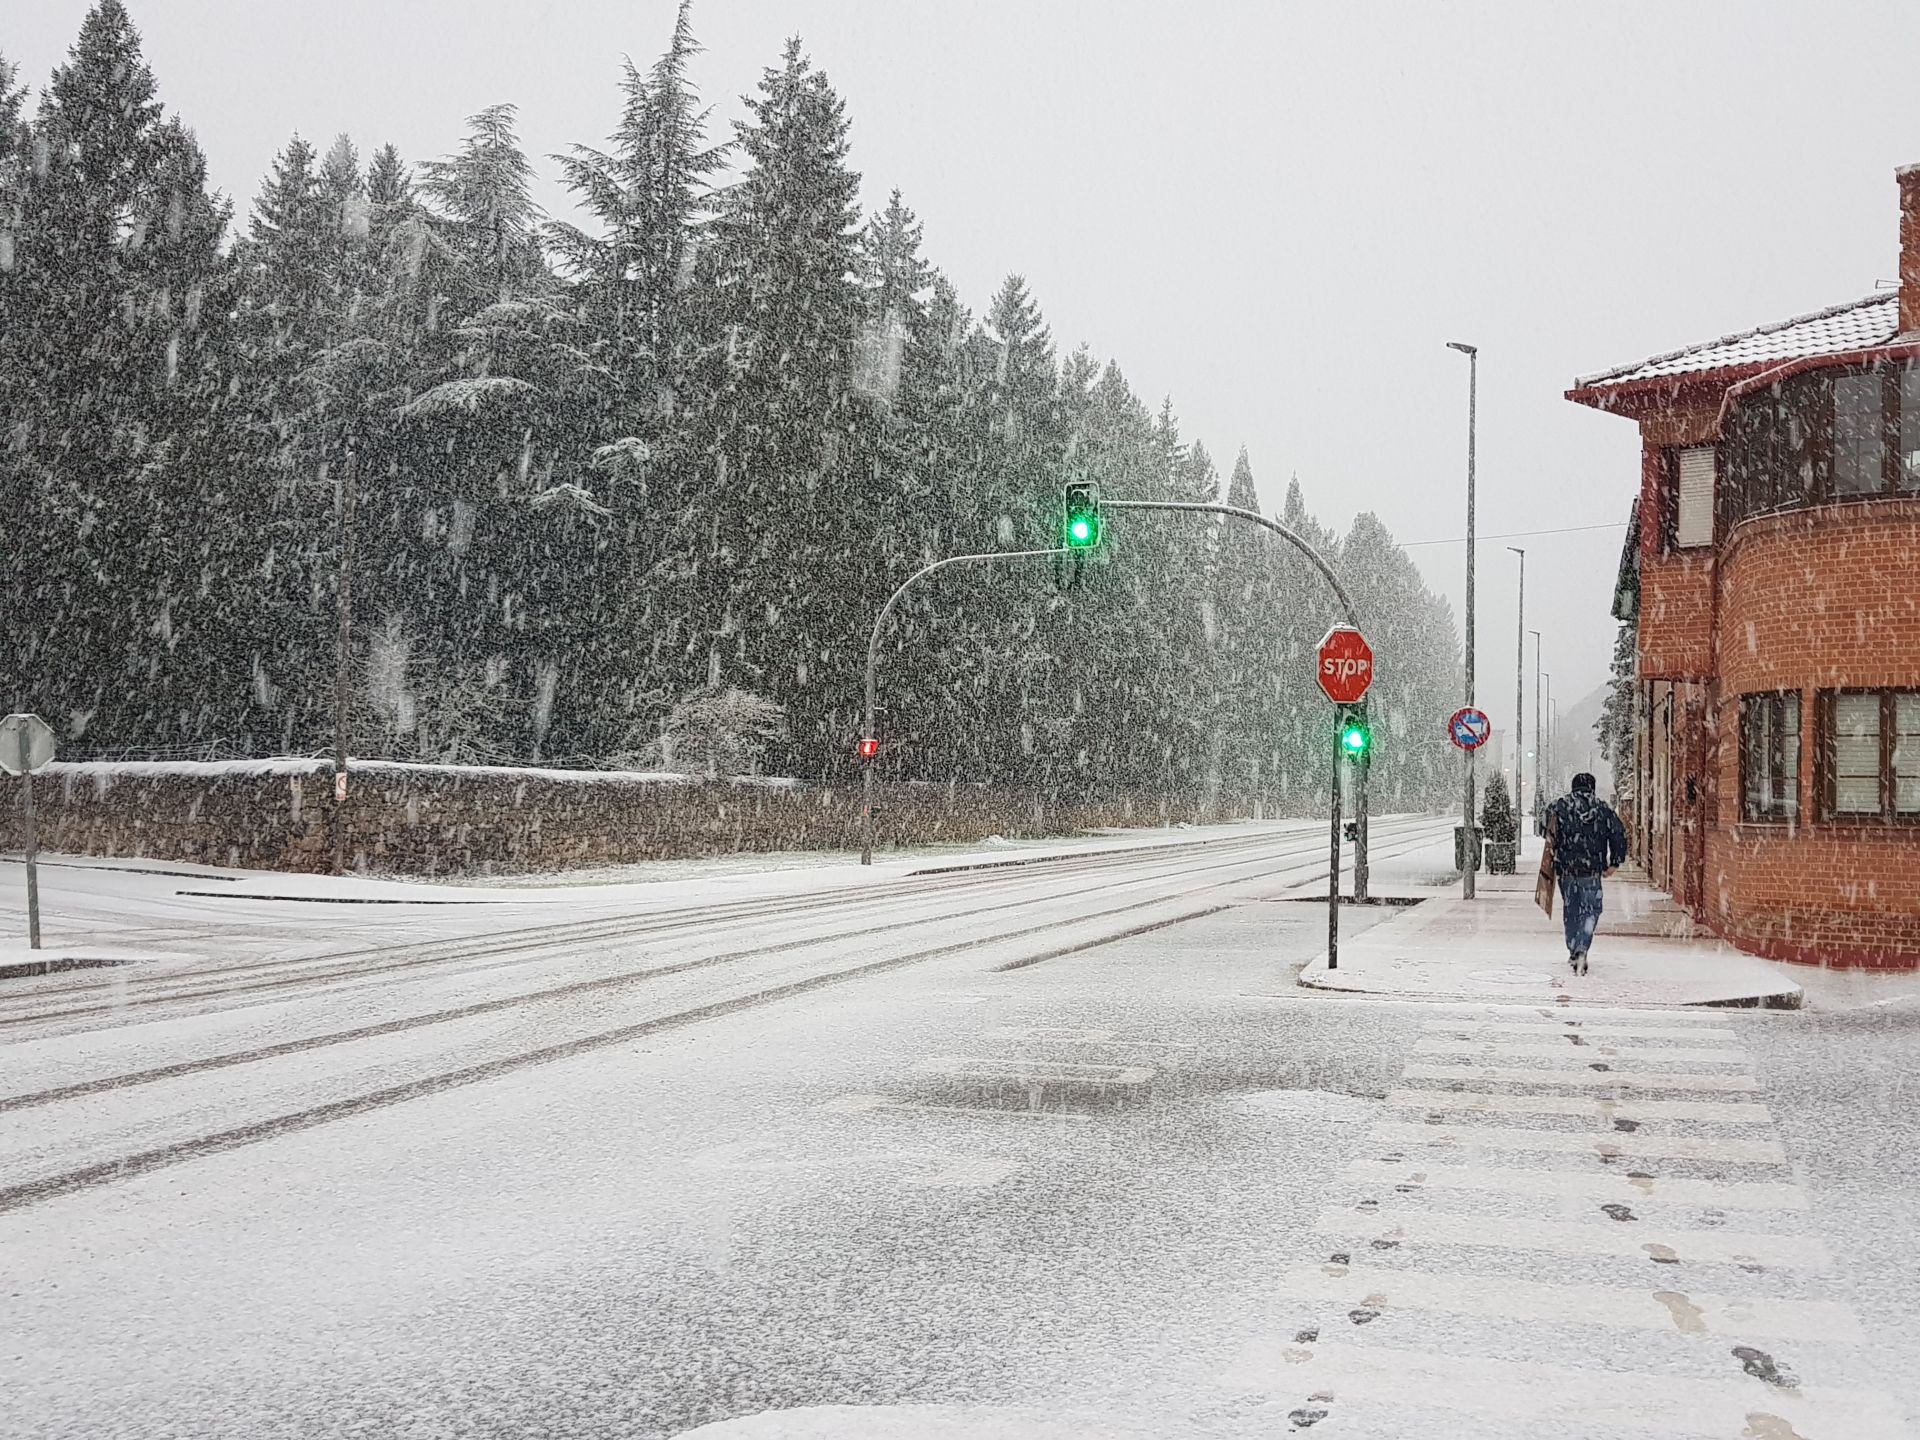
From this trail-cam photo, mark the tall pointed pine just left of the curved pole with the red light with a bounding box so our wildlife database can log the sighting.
[695,38,866,772]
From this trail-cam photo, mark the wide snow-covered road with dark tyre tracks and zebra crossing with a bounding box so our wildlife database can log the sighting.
[0,822,1920,1440]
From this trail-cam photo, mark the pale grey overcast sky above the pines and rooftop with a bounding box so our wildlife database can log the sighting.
[15,0,1920,728]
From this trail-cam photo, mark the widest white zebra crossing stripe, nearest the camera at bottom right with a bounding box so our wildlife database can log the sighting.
[1221,1340,1908,1440]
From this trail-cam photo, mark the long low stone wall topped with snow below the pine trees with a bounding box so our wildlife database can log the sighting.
[0,760,1196,876]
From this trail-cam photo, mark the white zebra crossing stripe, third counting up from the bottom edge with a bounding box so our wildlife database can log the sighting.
[1313,1208,1834,1273]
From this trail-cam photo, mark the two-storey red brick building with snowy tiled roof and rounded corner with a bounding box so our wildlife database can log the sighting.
[1567,165,1920,968]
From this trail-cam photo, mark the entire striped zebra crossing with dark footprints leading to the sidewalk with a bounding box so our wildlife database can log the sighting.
[1259,1010,1907,1440]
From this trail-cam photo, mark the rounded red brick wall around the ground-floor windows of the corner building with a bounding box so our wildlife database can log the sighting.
[1703,501,1920,968]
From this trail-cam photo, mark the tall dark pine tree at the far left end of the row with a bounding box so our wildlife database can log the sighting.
[0,0,240,745]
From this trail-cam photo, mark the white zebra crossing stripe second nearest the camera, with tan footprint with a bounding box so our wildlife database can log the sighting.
[1275,1265,1866,1344]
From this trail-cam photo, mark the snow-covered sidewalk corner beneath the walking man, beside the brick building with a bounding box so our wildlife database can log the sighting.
[1300,864,1801,1010]
